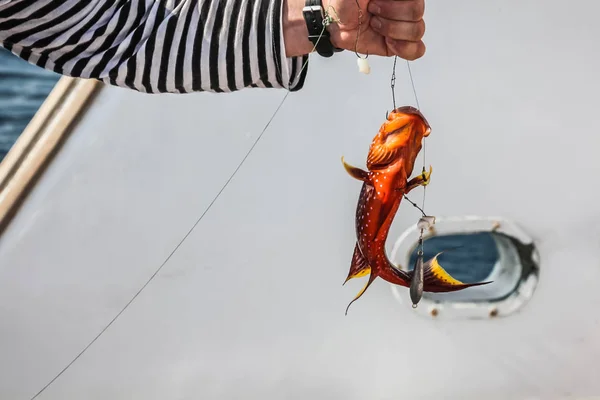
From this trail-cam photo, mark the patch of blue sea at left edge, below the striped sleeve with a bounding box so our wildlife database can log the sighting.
[0,48,60,161]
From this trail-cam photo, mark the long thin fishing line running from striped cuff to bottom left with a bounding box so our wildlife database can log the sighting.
[31,91,290,400]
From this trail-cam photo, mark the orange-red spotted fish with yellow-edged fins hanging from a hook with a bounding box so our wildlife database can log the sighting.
[342,106,489,314]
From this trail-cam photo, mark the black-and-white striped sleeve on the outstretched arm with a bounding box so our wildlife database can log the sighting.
[0,0,308,93]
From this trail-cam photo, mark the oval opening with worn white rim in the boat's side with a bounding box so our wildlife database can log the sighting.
[390,217,539,318]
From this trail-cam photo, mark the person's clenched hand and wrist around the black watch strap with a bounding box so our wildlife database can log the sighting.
[284,0,425,60]
